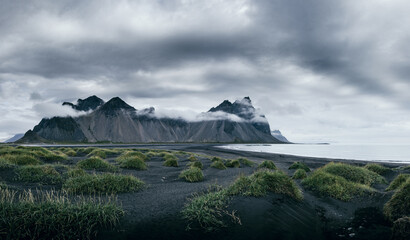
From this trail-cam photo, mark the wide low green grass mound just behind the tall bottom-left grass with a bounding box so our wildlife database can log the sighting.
[63,173,145,194]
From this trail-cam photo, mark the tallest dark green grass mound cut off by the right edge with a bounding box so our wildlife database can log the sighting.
[383,178,410,221]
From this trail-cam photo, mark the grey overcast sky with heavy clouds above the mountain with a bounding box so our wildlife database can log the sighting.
[0,0,410,143]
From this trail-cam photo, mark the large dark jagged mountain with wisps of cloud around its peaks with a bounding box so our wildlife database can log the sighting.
[19,96,281,143]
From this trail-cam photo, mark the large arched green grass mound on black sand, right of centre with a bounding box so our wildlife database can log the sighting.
[228,169,303,200]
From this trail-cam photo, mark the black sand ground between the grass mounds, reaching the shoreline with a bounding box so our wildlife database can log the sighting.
[3,144,408,239]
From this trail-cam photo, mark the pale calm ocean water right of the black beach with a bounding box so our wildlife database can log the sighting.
[221,144,410,164]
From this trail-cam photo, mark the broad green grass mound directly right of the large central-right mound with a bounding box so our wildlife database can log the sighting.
[302,169,370,201]
